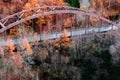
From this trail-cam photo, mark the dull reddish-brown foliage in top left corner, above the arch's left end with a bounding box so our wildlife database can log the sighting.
[0,0,27,19]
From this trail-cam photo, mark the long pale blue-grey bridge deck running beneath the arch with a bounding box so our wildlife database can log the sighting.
[0,25,115,46]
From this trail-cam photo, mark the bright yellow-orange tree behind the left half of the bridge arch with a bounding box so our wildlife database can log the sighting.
[23,0,52,30]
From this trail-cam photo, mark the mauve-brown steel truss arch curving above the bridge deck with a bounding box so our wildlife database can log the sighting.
[0,6,116,33]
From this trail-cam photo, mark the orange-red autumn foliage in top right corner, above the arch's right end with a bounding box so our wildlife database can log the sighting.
[90,0,120,18]
